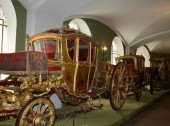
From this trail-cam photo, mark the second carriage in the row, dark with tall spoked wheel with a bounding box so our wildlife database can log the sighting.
[109,55,145,110]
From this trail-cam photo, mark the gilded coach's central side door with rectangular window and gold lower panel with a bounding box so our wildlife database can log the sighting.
[76,38,90,90]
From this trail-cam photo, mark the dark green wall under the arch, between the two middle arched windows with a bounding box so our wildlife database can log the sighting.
[64,18,117,62]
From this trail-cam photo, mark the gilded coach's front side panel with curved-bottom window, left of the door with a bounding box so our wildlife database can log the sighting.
[62,37,78,91]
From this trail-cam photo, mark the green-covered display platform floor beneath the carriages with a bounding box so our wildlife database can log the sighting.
[0,90,170,126]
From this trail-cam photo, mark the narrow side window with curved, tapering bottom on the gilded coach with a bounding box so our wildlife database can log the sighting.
[67,39,76,60]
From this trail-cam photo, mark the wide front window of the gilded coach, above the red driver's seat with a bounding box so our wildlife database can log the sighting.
[33,39,61,60]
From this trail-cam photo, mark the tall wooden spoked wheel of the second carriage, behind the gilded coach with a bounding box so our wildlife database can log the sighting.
[109,63,128,110]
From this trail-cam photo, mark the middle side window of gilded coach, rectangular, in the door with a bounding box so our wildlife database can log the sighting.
[79,39,89,61]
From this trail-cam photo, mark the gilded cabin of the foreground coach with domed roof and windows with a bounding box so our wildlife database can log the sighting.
[29,29,100,92]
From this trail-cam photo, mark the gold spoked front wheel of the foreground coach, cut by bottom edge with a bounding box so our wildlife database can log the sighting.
[15,97,56,126]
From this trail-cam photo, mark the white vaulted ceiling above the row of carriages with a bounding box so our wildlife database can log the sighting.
[18,0,170,54]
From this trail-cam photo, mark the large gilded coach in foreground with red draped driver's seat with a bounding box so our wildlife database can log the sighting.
[0,28,106,126]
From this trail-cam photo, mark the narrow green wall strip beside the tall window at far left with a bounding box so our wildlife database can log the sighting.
[11,0,27,51]
